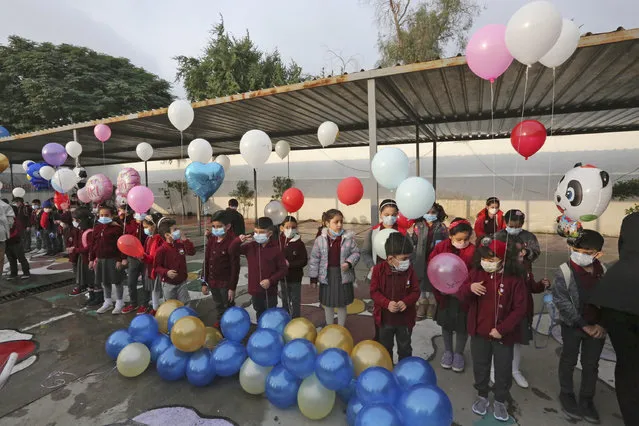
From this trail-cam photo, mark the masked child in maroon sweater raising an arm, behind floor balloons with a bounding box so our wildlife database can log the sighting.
[229,217,288,320]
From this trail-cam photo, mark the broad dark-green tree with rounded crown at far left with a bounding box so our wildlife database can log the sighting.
[0,36,173,133]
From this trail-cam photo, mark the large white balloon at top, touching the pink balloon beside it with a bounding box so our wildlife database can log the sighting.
[506,0,562,65]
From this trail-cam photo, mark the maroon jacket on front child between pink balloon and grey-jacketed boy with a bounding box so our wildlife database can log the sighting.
[458,269,528,345]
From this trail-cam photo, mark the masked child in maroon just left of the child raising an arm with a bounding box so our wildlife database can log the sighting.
[202,210,240,327]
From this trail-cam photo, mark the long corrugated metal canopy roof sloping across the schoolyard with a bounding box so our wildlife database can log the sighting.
[0,28,639,166]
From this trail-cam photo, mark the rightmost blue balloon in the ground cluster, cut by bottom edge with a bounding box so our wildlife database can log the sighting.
[396,385,453,426]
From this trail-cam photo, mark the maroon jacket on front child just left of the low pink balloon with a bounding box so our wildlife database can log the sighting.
[371,262,420,328]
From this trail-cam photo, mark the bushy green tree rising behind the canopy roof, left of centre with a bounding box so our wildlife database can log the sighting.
[174,17,304,101]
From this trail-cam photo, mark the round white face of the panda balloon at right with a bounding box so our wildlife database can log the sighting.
[555,163,612,222]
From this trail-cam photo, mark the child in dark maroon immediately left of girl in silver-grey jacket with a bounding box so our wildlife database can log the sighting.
[280,216,308,318]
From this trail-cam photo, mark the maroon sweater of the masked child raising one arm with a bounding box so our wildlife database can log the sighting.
[229,237,288,297]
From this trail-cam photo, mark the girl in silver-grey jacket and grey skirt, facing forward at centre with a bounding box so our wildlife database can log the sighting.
[308,209,360,326]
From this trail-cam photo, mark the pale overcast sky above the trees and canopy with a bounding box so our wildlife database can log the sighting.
[0,0,639,97]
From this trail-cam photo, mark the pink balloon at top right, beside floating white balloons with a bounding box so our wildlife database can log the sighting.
[466,24,513,83]
